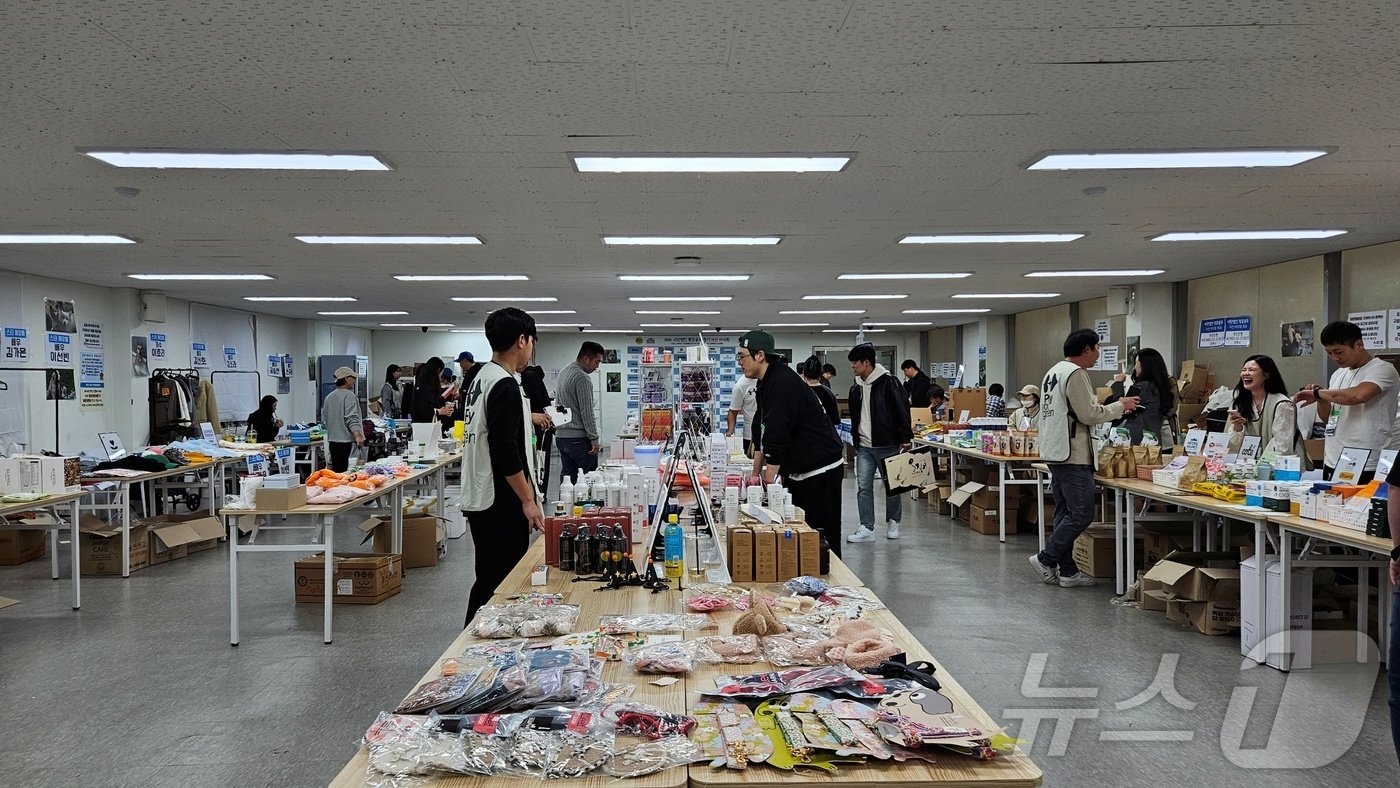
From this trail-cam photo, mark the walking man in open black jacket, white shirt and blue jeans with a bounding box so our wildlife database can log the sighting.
[846,344,927,542]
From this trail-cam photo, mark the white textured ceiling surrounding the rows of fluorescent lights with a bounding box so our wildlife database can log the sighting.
[0,0,1400,329]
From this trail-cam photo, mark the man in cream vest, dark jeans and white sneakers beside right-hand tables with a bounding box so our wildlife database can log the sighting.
[1030,329,1138,588]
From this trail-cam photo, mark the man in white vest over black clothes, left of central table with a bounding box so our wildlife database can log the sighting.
[458,307,549,627]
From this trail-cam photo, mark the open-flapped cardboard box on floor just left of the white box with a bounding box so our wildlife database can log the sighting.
[1138,550,1240,635]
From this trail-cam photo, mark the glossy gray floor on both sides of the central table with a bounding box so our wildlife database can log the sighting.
[0,473,1400,788]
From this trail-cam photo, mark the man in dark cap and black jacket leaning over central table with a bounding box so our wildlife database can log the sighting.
[738,332,846,556]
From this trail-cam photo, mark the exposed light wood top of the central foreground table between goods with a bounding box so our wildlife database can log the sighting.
[332,539,1040,788]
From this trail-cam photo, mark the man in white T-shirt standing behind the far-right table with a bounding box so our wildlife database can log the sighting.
[1294,321,1400,484]
